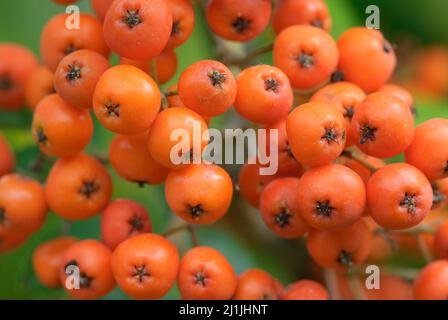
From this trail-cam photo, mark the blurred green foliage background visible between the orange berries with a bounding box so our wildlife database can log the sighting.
[0,0,448,299]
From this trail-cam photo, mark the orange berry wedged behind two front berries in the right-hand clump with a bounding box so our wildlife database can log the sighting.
[310,82,366,146]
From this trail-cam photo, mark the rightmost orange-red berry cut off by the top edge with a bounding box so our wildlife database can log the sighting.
[272,0,332,34]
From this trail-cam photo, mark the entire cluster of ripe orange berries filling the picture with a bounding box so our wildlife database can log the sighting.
[0,0,448,299]
